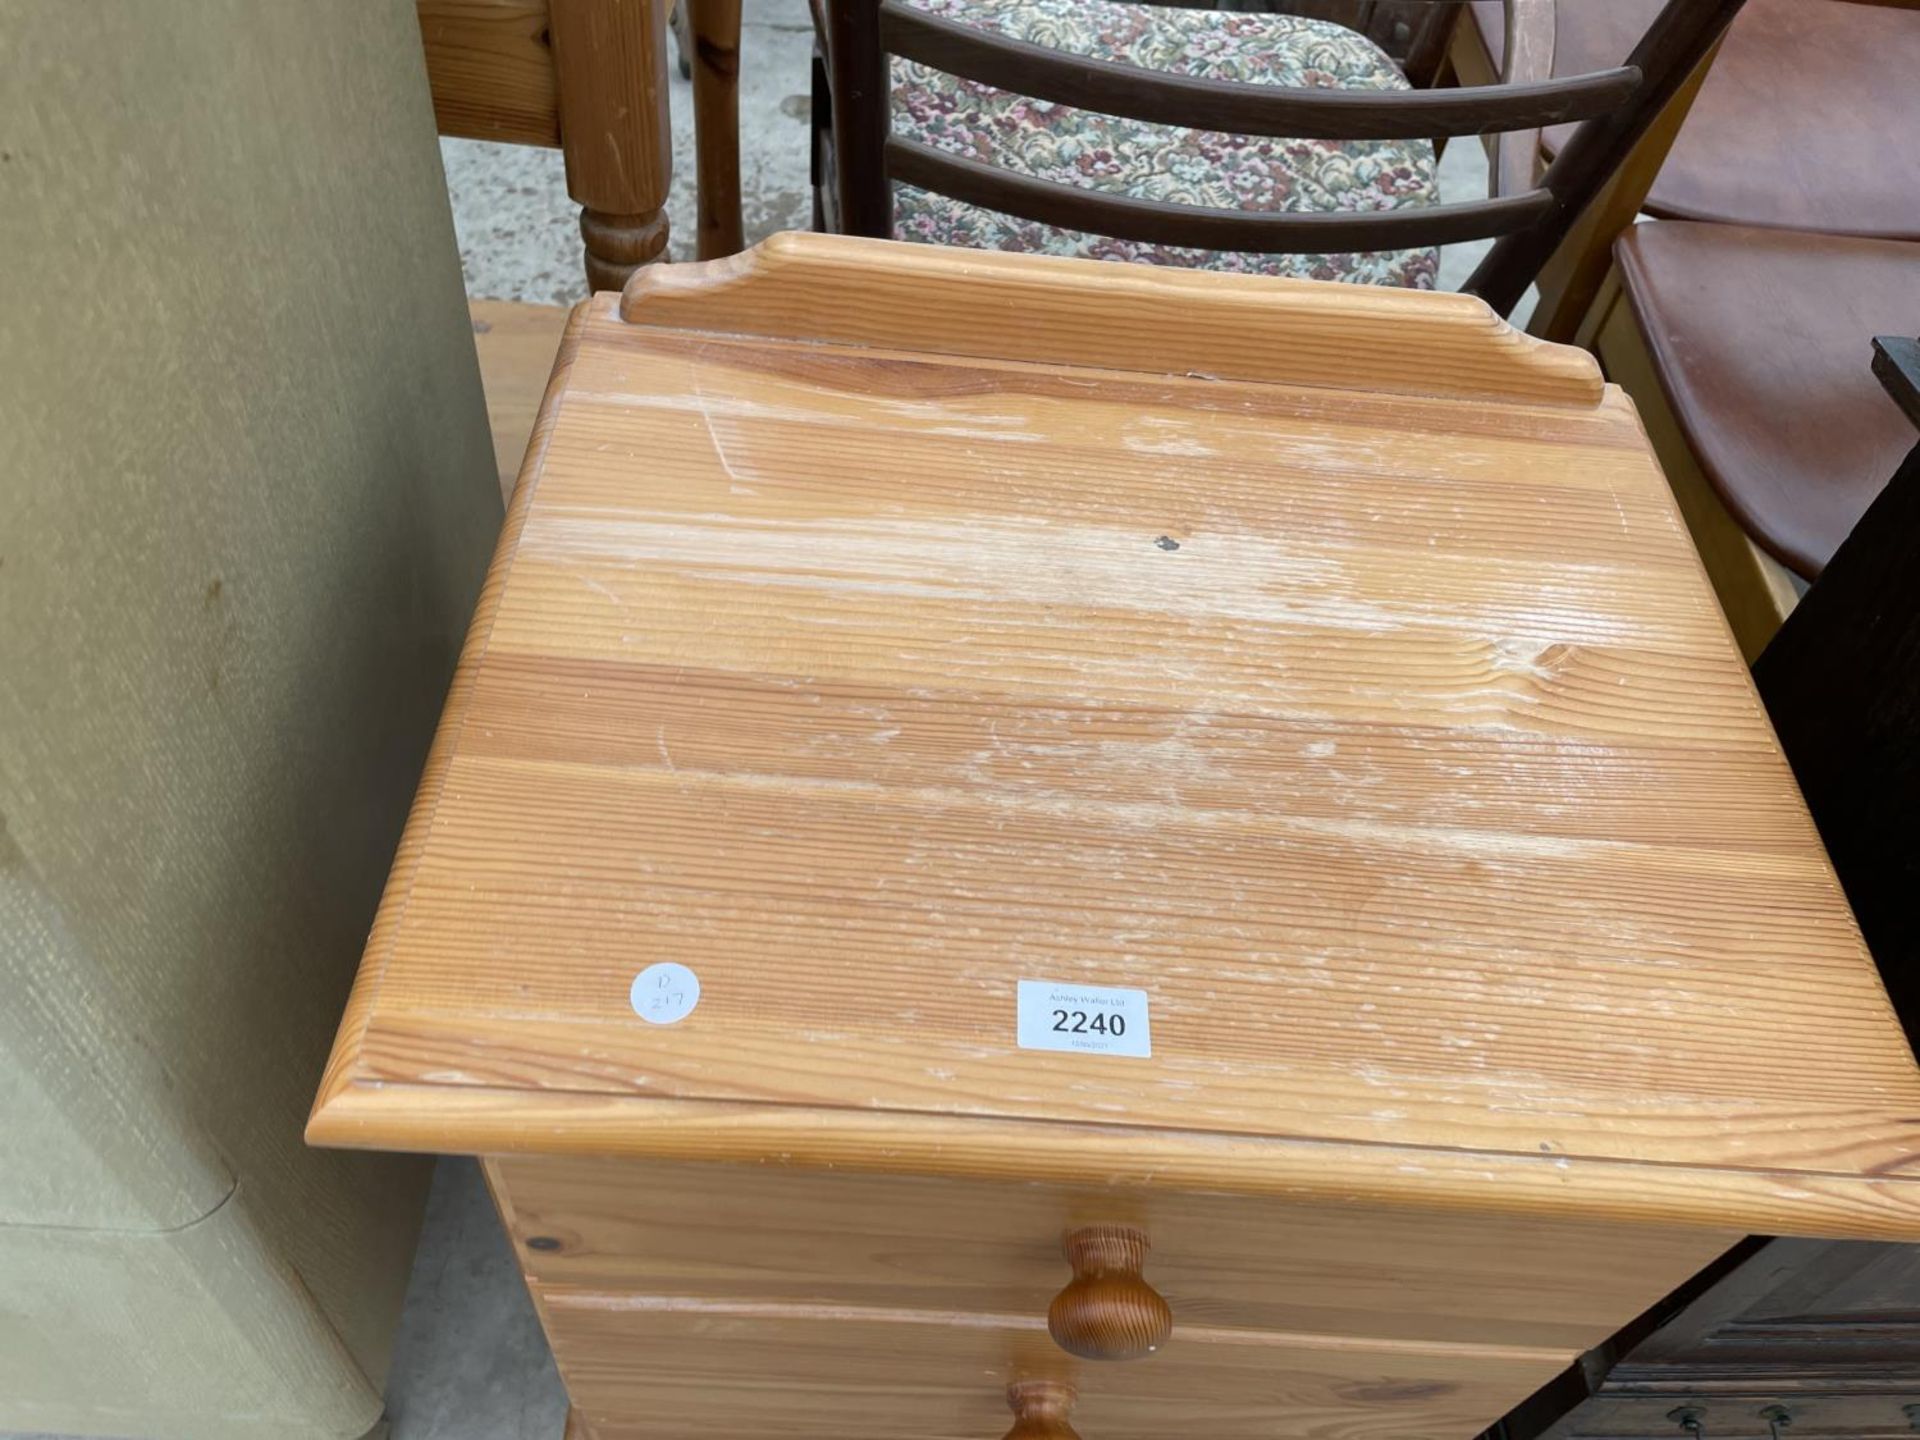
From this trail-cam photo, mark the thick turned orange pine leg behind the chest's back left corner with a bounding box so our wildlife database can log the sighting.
[549,0,674,290]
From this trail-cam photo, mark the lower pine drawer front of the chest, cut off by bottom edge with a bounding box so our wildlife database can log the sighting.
[541,1290,1551,1440]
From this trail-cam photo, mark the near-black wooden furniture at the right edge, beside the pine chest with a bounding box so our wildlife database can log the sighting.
[1753,340,1920,1048]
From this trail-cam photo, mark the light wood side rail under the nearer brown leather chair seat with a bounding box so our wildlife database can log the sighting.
[1576,273,1801,662]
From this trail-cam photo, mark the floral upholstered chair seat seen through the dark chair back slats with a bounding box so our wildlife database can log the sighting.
[893,0,1440,290]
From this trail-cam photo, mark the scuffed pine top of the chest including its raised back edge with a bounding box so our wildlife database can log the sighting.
[311,238,1920,1235]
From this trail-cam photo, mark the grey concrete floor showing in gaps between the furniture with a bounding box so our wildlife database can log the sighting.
[0,14,1532,1440]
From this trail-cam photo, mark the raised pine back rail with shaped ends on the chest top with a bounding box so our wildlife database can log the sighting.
[620,234,1603,407]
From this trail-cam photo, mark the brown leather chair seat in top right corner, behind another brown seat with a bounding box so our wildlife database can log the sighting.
[1473,0,1920,240]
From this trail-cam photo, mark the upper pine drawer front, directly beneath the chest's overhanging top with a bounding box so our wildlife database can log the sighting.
[490,1158,1738,1363]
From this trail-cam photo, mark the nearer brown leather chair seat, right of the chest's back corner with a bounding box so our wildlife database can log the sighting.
[1615,221,1920,580]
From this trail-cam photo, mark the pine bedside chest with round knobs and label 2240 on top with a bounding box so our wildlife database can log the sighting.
[309,236,1920,1440]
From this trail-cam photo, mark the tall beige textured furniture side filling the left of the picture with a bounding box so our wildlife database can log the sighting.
[0,0,501,1440]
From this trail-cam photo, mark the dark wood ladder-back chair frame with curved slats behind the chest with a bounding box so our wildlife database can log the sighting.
[824,0,1743,315]
